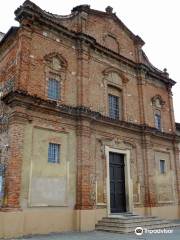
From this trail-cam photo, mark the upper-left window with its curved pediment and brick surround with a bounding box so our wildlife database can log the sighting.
[45,53,67,101]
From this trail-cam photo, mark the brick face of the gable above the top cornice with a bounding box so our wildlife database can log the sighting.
[59,13,136,60]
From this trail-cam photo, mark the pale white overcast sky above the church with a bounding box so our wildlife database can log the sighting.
[0,0,180,122]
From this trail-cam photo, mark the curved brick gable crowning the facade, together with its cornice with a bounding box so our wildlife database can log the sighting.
[13,0,175,86]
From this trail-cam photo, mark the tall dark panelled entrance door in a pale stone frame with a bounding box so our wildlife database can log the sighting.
[109,152,126,213]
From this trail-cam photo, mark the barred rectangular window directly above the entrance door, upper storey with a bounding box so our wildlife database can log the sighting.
[109,94,119,119]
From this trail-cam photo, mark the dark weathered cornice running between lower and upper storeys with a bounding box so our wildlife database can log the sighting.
[3,91,180,141]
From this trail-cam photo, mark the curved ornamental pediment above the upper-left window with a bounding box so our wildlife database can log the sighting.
[44,52,67,71]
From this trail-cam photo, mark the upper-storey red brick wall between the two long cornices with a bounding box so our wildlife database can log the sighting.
[1,23,175,132]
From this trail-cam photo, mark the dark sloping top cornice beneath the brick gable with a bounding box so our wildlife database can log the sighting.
[15,0,175,86]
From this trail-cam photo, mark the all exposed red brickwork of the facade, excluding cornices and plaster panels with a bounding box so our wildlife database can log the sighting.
[0,1,179,213]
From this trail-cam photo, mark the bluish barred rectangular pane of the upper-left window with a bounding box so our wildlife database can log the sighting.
[48,78,60,100]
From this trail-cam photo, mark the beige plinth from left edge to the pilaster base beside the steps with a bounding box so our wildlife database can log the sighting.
[0,208,75,238]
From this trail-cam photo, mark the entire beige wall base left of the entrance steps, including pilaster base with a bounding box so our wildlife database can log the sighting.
[0,207,106,238]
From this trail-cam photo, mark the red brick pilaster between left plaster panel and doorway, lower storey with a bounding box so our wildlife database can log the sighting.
[76,120,96,210]
